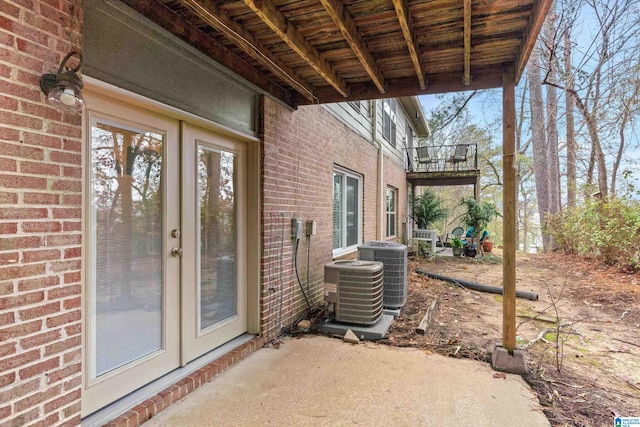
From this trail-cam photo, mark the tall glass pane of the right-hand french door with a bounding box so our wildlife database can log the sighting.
[198,146,238,330]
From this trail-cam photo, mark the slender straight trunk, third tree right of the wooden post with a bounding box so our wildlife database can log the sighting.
[564,30,578,208]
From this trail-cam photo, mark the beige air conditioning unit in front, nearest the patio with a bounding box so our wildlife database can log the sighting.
[324,261,383,325]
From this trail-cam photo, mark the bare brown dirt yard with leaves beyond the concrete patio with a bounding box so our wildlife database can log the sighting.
[381,249,640,426]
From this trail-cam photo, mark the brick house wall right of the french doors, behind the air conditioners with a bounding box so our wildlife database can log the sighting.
[261,99,406,338]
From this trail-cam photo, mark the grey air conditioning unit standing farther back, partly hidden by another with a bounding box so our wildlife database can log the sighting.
[358,240,407,309]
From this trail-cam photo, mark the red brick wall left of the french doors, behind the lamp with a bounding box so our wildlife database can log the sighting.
[0,0,82,426]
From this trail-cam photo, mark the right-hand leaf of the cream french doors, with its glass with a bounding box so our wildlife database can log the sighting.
[182,123,247,364]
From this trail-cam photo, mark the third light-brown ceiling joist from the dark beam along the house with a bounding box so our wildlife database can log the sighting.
[320,0,385,93]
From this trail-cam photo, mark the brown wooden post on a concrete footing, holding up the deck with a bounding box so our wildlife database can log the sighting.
[502,66,517,352]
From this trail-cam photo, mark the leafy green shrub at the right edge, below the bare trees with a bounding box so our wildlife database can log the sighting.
[547,198,640,270]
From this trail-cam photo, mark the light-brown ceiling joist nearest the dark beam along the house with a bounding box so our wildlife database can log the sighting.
[179,0,314,100]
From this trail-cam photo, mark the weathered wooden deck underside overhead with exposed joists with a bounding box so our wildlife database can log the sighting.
[123,0,551,108]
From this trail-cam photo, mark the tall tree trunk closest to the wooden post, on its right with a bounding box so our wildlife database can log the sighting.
[527,48,550,251]
